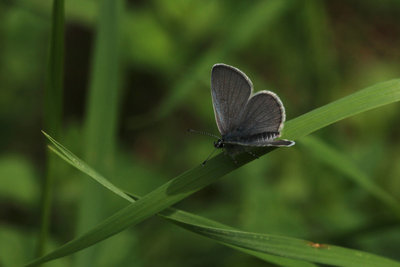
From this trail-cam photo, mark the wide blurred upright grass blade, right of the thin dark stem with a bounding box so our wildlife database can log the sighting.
[74,0,122,266]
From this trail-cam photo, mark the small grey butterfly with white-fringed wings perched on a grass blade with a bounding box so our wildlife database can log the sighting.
[211,63,295,162]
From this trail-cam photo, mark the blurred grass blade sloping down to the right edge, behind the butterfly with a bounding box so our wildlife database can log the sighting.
[299,136,400,218]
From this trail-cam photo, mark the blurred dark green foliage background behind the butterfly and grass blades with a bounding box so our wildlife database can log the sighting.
[0,0,400,266]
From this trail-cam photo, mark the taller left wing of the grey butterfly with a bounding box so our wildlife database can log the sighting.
[211,64,253,136]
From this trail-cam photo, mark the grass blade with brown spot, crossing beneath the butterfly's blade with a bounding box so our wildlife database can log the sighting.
[43,136,398,266]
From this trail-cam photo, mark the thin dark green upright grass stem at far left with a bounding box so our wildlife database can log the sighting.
[36,0,64,257]
